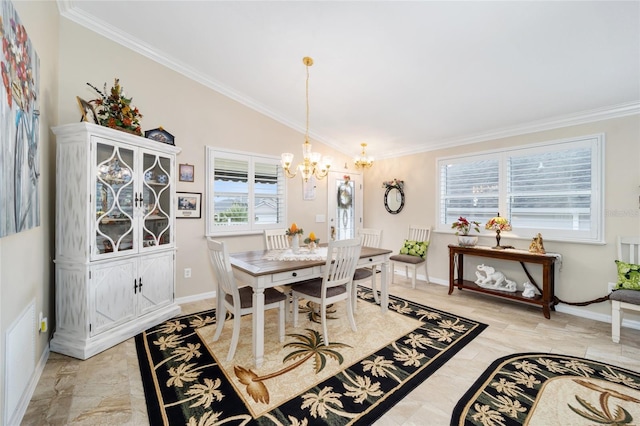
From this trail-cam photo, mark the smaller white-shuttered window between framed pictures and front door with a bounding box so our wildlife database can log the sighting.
[206,147,286,236]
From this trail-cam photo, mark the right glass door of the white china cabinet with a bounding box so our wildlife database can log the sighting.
[142,152,173,249]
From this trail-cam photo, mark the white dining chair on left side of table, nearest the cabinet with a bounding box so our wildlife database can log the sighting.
[207,237,287,361]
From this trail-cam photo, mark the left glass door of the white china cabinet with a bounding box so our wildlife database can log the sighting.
[93,143,135,255]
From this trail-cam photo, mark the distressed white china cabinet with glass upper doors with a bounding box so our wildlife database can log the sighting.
[51,122,180,359]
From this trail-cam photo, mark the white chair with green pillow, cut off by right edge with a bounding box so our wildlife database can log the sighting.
[609,236,640,343]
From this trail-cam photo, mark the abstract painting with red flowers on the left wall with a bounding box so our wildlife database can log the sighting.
[0,0,40,237]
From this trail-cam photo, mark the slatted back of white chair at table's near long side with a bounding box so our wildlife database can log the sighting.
[322,238,362,287]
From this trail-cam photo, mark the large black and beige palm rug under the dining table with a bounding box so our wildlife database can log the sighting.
[135,287,486,426]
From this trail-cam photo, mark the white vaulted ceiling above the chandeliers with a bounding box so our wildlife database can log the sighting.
[58,0,640,158]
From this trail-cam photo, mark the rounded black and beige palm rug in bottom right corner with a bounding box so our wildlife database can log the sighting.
[451,353,640,426]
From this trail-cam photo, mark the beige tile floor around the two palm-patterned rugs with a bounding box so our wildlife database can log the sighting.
[22,276,640,426]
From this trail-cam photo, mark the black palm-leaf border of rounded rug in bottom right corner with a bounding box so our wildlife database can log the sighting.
[450,352,640,426]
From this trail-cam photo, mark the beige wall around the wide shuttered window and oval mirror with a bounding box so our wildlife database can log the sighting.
[364,115,640,319]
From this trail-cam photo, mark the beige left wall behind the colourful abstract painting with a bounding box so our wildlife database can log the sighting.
[0,1,58,422]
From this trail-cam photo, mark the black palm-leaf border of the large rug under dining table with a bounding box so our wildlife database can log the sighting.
[135,287,487,425]
